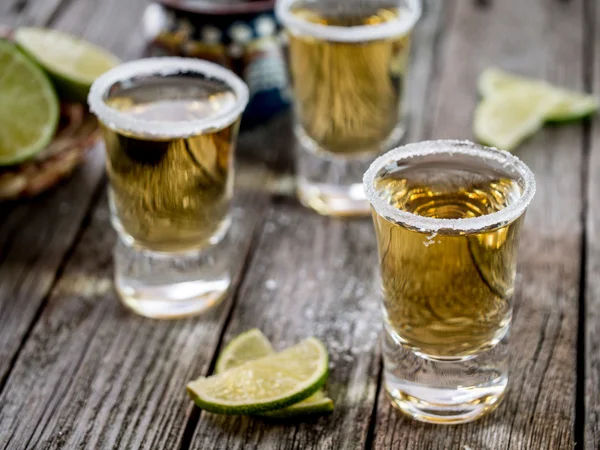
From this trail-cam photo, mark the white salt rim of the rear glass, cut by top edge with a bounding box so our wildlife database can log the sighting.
[275,0,421,42]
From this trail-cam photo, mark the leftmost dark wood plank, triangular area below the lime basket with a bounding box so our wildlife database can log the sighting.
[0,148,104,381]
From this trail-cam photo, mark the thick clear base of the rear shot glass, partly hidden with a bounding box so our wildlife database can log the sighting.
[294,123,405,216]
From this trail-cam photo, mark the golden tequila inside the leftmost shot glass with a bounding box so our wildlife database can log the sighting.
[103,79,239,252]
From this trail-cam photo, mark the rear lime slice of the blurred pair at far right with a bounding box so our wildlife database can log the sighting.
[478,67,599,122]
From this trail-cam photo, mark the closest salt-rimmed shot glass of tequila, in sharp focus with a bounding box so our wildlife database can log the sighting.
[363,140,535,424]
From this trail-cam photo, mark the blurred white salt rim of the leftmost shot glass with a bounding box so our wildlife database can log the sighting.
[88,57,249,138]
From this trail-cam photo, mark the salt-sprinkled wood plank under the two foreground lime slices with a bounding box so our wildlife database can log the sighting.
[190,1,447,450]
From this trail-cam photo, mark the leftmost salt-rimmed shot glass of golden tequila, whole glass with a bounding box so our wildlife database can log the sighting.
[88,58,249,318]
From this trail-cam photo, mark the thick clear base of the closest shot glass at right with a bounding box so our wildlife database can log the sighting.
[383,326,508,424]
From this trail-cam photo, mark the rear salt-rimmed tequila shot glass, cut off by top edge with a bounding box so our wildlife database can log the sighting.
[276,0,421,216]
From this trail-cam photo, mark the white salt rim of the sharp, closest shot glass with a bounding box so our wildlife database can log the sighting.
[363,140,535,232]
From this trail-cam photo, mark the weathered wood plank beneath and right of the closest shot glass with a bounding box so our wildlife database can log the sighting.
[375,0,584,450]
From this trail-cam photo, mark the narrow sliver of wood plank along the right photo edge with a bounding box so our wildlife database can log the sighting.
[581,1,600,450]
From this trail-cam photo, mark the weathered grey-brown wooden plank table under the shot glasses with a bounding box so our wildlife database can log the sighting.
[0,0,600,450]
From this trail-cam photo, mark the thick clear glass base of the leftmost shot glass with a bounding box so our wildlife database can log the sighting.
[114,236,232,319]
